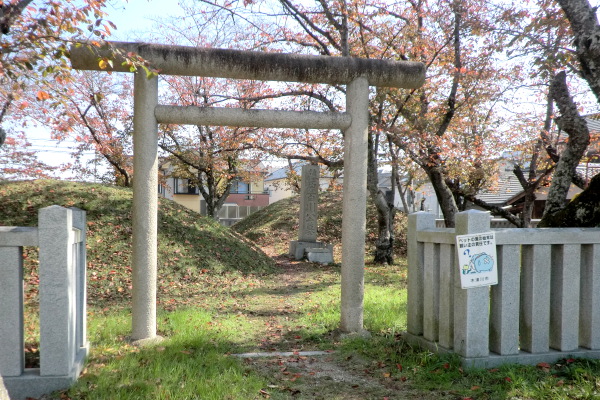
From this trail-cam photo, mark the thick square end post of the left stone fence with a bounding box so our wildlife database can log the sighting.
[38,206,87,377]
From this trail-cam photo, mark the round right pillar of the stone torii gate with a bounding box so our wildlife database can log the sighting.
[340,78,369,333]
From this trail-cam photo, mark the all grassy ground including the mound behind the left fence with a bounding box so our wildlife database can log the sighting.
[0,181,600,399]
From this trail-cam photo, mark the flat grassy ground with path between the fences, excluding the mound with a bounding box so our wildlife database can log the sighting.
[68,262,600,399]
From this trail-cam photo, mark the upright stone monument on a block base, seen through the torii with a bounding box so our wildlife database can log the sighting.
[289,165,333,264]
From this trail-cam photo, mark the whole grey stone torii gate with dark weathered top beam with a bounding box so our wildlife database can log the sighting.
[71,42,425,342]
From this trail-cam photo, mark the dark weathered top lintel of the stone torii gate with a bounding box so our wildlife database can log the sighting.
[71,42,425,89]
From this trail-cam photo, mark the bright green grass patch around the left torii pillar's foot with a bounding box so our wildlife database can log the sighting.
[68,310,265,400]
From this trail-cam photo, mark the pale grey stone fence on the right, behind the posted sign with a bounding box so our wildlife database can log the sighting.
[405,211,600,367]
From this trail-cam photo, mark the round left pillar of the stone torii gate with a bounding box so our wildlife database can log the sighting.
[131,71,158,344]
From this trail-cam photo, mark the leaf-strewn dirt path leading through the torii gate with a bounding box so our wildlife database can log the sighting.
[234,248,452,399]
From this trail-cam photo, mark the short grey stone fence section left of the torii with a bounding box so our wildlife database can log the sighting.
[0,206,89,400]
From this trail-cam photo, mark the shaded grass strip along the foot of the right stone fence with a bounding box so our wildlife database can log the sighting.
[340,334,600,400]
